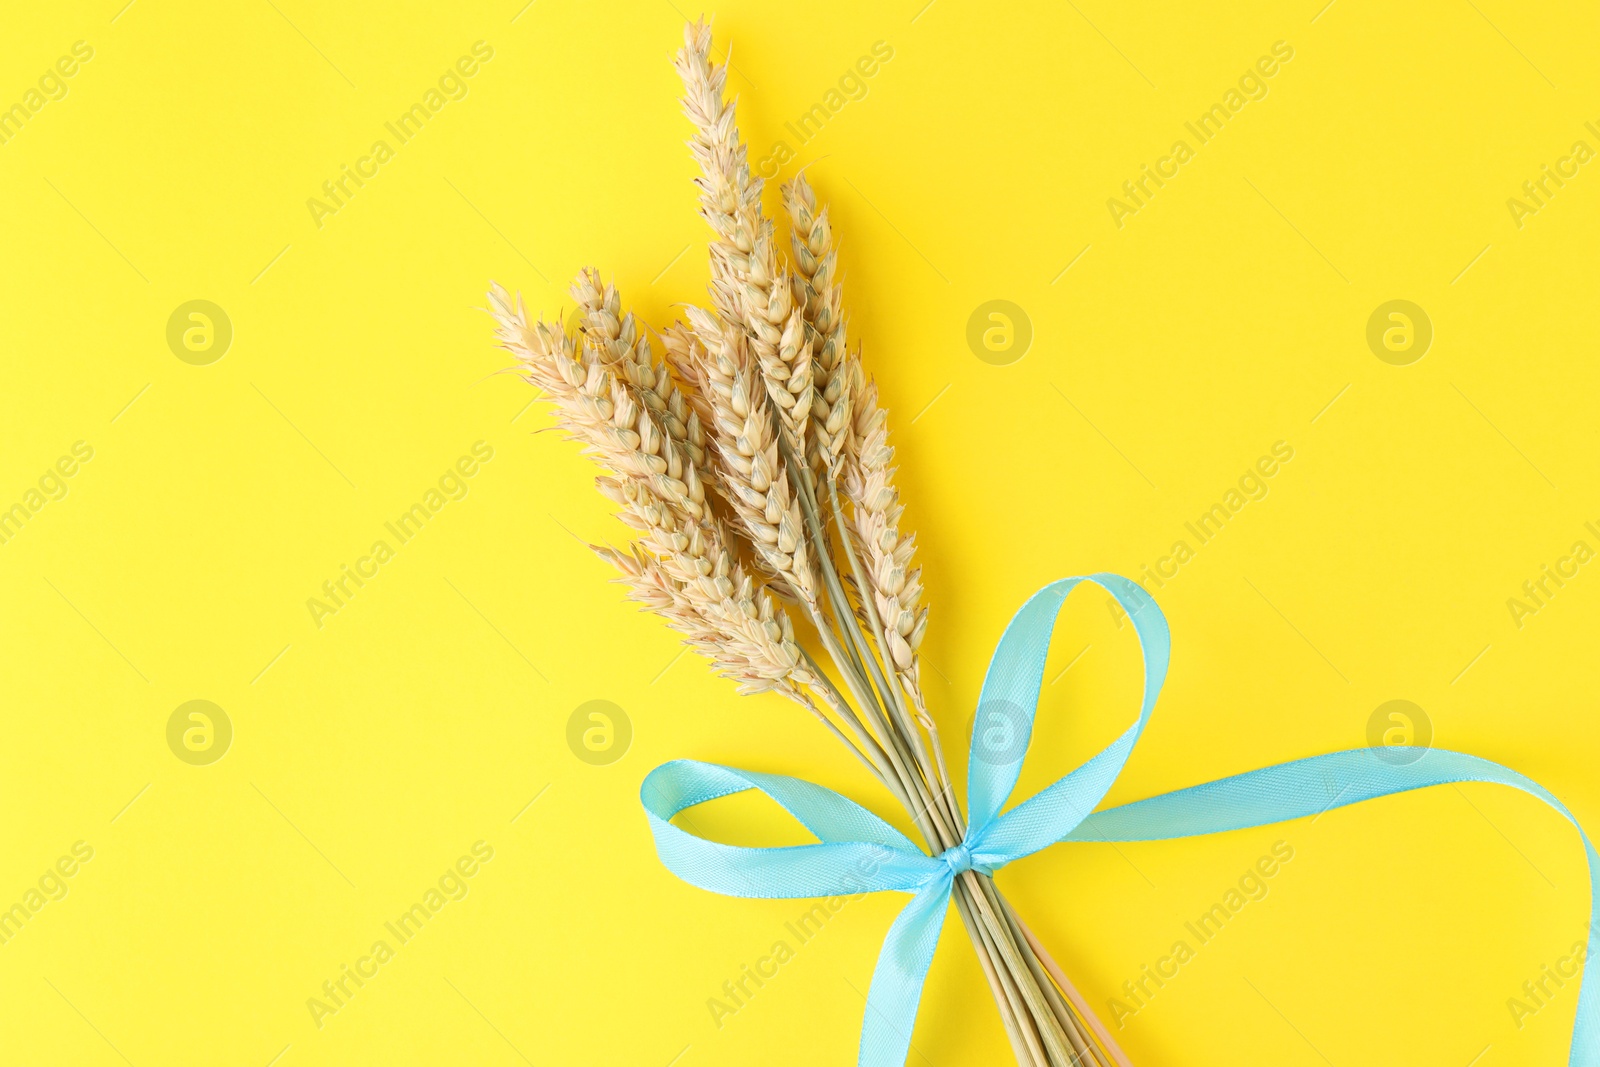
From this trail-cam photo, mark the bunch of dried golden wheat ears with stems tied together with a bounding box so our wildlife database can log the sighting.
[490,22,1126,1067]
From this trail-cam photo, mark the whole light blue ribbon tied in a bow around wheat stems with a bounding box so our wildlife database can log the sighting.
[640,574,1600,1067]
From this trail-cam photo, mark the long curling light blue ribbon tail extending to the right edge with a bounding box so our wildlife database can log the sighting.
[1061,747,1600,1067]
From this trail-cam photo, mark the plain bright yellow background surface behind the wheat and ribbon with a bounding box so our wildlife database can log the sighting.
[0,0,1600,1067]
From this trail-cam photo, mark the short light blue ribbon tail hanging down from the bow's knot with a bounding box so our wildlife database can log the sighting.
[856,873,954,1067]
